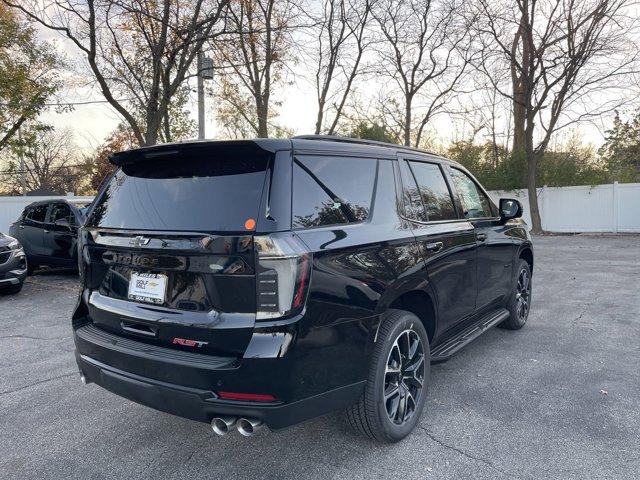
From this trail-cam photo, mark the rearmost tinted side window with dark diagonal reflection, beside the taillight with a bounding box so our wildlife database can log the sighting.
[292,155,377,228]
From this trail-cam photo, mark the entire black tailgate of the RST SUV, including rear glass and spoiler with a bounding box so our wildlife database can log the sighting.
[82,142,290,355]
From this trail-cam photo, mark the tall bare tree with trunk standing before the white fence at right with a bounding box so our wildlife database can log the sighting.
[478,0,638,232]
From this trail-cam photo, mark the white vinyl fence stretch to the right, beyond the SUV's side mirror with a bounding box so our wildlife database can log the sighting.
[489,182,640,233]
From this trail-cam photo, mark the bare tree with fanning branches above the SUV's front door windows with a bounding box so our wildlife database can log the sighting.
[372,0,473,146]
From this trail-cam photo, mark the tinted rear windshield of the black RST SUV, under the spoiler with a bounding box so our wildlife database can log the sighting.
[86,151,270,231]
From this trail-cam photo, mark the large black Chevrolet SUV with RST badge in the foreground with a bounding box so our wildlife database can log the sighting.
[73,136,533,442]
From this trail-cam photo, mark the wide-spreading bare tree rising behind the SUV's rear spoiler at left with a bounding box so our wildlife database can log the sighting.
[1,0,229,145]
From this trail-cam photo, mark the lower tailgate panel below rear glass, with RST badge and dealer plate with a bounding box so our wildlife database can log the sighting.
[84,230,256,354]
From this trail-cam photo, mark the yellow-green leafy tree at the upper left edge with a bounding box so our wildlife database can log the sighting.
[0,3,62,151]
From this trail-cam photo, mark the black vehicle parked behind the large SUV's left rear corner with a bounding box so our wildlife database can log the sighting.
[9,200,84,273]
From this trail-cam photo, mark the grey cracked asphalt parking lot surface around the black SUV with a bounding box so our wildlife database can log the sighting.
[0,236,640,479]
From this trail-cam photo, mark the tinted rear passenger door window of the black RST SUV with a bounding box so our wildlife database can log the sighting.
[409,162,458,221]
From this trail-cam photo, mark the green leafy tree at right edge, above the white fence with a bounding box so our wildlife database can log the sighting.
[599,111,640,182]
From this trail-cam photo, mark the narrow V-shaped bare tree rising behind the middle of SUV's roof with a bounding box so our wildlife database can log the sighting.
[314,0,371,135]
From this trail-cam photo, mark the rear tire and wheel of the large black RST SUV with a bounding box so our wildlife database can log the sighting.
[347,310,431,443]
